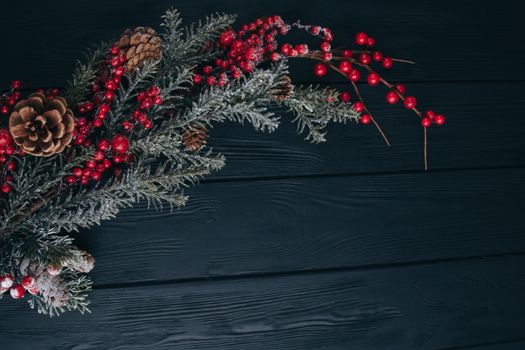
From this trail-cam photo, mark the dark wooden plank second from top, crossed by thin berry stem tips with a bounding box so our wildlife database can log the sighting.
[209,83,525,178]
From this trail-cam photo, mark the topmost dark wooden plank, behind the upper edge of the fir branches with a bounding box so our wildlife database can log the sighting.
[0,0,525,86]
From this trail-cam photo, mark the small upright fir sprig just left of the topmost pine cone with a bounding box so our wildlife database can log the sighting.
[64,43,109,106]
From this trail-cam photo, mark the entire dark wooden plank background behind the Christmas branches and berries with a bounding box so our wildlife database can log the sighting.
[0,0,525,350]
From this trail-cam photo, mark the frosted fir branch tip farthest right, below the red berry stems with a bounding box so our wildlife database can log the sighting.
[282,86,360,143]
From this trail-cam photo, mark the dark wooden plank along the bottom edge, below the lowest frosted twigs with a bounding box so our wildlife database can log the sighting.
[0,257,525,350]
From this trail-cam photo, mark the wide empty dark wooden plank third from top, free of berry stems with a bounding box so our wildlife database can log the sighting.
[68,169,525,284]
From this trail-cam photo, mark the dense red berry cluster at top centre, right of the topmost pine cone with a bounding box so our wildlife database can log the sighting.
[193,15,289,86]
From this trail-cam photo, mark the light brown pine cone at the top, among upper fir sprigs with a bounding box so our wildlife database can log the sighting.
[116,27,162,72]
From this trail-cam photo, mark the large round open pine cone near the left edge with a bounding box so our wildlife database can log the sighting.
[9,93,75,157]
